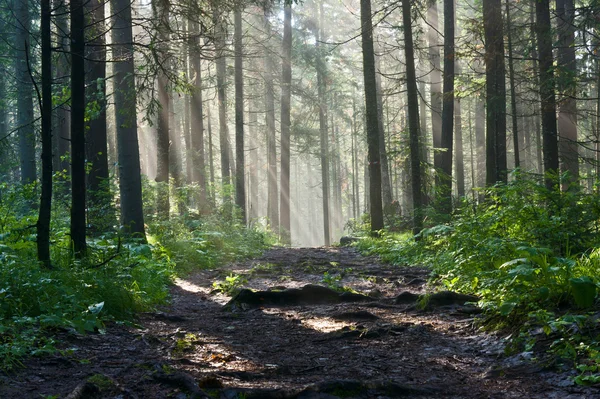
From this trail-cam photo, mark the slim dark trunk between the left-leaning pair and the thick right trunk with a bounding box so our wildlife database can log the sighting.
[439,0,455,215]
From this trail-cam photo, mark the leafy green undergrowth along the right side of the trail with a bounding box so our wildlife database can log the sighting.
[356,175,600,384]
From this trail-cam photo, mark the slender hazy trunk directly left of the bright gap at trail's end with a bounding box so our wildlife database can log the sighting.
[279,3,292,245]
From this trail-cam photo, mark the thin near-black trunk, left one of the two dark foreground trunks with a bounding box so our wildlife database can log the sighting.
[37,0,52,269]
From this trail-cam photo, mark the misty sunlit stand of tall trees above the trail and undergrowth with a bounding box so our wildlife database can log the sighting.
[0,0,600,256]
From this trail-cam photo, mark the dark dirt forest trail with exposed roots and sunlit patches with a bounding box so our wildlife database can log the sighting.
[0,247,600,399]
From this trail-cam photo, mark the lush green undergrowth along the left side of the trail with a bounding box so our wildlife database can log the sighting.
[0,184,270,371]
